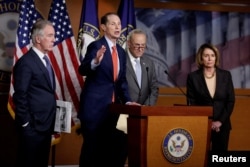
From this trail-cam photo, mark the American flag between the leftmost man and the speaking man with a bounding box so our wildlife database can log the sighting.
[48,0,84,138]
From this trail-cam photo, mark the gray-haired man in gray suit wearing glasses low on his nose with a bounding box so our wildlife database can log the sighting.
[126,29,159,106]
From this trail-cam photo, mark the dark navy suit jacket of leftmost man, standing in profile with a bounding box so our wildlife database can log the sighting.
[13,49,56,131]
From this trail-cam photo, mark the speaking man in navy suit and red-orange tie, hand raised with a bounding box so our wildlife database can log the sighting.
[78,13,140,167]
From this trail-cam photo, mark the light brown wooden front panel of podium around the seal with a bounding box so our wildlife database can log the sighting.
[146,116,208,167]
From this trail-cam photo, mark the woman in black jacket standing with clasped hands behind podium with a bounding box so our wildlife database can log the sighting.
[187,44,235,152]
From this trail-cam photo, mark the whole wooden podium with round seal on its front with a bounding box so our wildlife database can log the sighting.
[110,104,212,167]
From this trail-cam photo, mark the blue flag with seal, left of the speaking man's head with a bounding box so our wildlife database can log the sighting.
[77,0,100,60]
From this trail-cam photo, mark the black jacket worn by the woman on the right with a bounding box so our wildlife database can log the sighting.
[187,68,235,128]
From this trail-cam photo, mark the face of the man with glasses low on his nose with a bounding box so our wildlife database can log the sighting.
[128,34,146,58]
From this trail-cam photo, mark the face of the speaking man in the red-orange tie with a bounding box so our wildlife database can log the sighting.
[101,15,121,40]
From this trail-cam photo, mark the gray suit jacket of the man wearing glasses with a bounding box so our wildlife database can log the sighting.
[126,55,158,106]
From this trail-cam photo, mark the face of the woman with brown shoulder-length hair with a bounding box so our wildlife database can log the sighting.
[202,48,216,68]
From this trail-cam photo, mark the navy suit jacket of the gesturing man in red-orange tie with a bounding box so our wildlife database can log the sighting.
[78,37,130,130]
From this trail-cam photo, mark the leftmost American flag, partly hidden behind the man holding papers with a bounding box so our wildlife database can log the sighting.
[8,0,42,118]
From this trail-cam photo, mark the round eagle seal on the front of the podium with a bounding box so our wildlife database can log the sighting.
[162,128,194,163]
